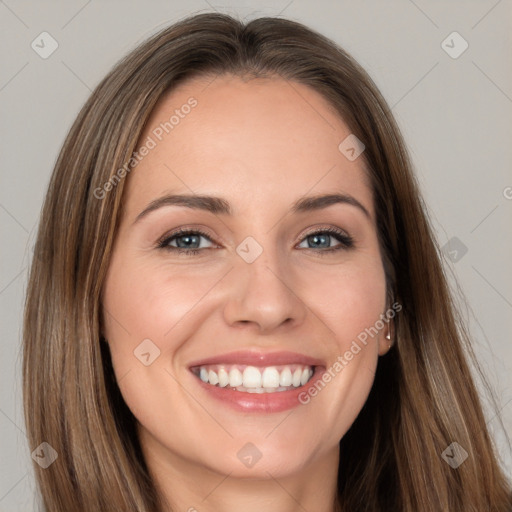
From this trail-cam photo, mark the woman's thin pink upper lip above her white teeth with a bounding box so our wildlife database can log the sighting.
[189,350,324,368]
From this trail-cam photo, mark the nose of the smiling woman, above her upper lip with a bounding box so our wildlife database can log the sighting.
[224,245,308,334]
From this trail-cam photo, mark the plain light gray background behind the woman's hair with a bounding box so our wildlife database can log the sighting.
[0,0,512,512]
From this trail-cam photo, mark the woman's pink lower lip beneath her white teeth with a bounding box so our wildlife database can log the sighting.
[190,366,324,413]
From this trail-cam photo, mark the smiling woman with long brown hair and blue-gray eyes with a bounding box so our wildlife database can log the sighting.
[23,14,512,512]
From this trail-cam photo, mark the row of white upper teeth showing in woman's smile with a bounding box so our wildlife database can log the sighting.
[195,365,313,392]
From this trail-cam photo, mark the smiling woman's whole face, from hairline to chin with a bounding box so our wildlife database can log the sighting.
[103,76,388,478]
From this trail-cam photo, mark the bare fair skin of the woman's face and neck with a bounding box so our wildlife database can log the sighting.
[102,76,389,512]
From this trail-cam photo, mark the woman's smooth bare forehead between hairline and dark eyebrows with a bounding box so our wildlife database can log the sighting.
[125,75,373,220]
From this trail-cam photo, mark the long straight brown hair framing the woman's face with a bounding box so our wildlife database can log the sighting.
[23,14,512,512]
